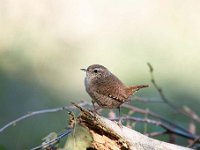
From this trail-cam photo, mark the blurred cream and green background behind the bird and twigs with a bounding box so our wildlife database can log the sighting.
[0,0,200,149]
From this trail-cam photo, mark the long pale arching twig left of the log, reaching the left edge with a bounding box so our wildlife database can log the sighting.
[0,102,88,133]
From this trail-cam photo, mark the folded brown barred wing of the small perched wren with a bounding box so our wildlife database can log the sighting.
[95,75,128,102]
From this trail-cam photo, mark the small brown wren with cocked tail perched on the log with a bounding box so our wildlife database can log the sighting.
[81,64,148,122]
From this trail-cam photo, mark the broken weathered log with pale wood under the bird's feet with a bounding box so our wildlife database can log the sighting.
[65,105,192,150]
